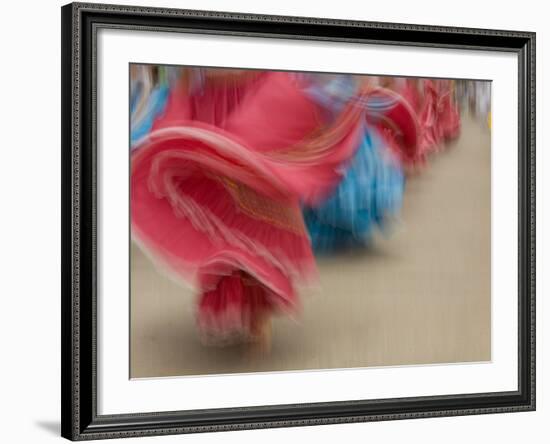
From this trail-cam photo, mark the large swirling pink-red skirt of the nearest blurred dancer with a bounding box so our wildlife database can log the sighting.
[131,72,363,337]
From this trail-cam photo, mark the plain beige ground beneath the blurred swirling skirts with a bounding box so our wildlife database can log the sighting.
[130,117,491,377]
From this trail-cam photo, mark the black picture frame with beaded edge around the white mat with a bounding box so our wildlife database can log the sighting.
[61,3,535,440]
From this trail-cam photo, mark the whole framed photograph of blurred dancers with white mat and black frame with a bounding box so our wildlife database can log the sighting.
[61,3,535,440]
